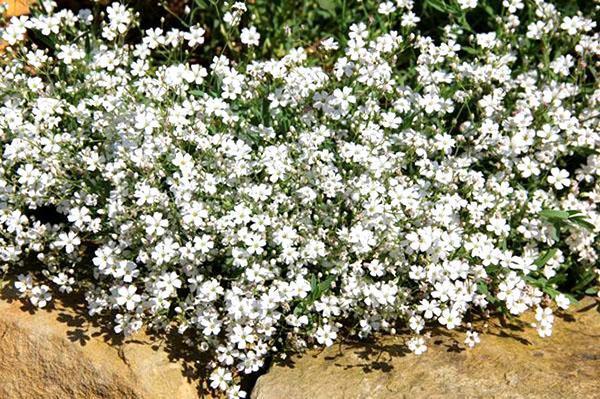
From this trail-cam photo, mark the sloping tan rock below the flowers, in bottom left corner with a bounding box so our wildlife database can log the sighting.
[0,289,200,399]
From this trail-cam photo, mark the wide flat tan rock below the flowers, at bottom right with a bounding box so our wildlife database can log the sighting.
[252,298,600,399]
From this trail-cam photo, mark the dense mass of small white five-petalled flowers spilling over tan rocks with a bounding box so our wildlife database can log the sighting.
[0,0,600,398]
